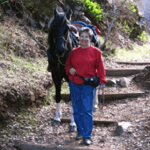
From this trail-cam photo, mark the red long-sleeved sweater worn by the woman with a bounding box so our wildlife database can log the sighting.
[65,46,106,84]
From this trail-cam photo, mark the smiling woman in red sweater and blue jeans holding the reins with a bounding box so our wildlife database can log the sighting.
[65,27,105,145]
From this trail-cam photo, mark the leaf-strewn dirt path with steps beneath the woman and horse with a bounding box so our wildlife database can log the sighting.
[0,62,150,150]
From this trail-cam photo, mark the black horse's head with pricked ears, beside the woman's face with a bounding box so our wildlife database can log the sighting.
[50,9,75,57]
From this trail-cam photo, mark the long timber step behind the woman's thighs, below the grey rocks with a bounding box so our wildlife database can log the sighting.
[61,91,145,101]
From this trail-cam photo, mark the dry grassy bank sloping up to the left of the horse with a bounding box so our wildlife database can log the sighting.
[0,18,54,118]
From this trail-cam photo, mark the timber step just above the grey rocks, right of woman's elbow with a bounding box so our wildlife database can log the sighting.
[106,68,143,76]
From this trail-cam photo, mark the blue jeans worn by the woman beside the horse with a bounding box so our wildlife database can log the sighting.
[69,81,95,139]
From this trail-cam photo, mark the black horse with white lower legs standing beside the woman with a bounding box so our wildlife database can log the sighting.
[47,9,102,132]
